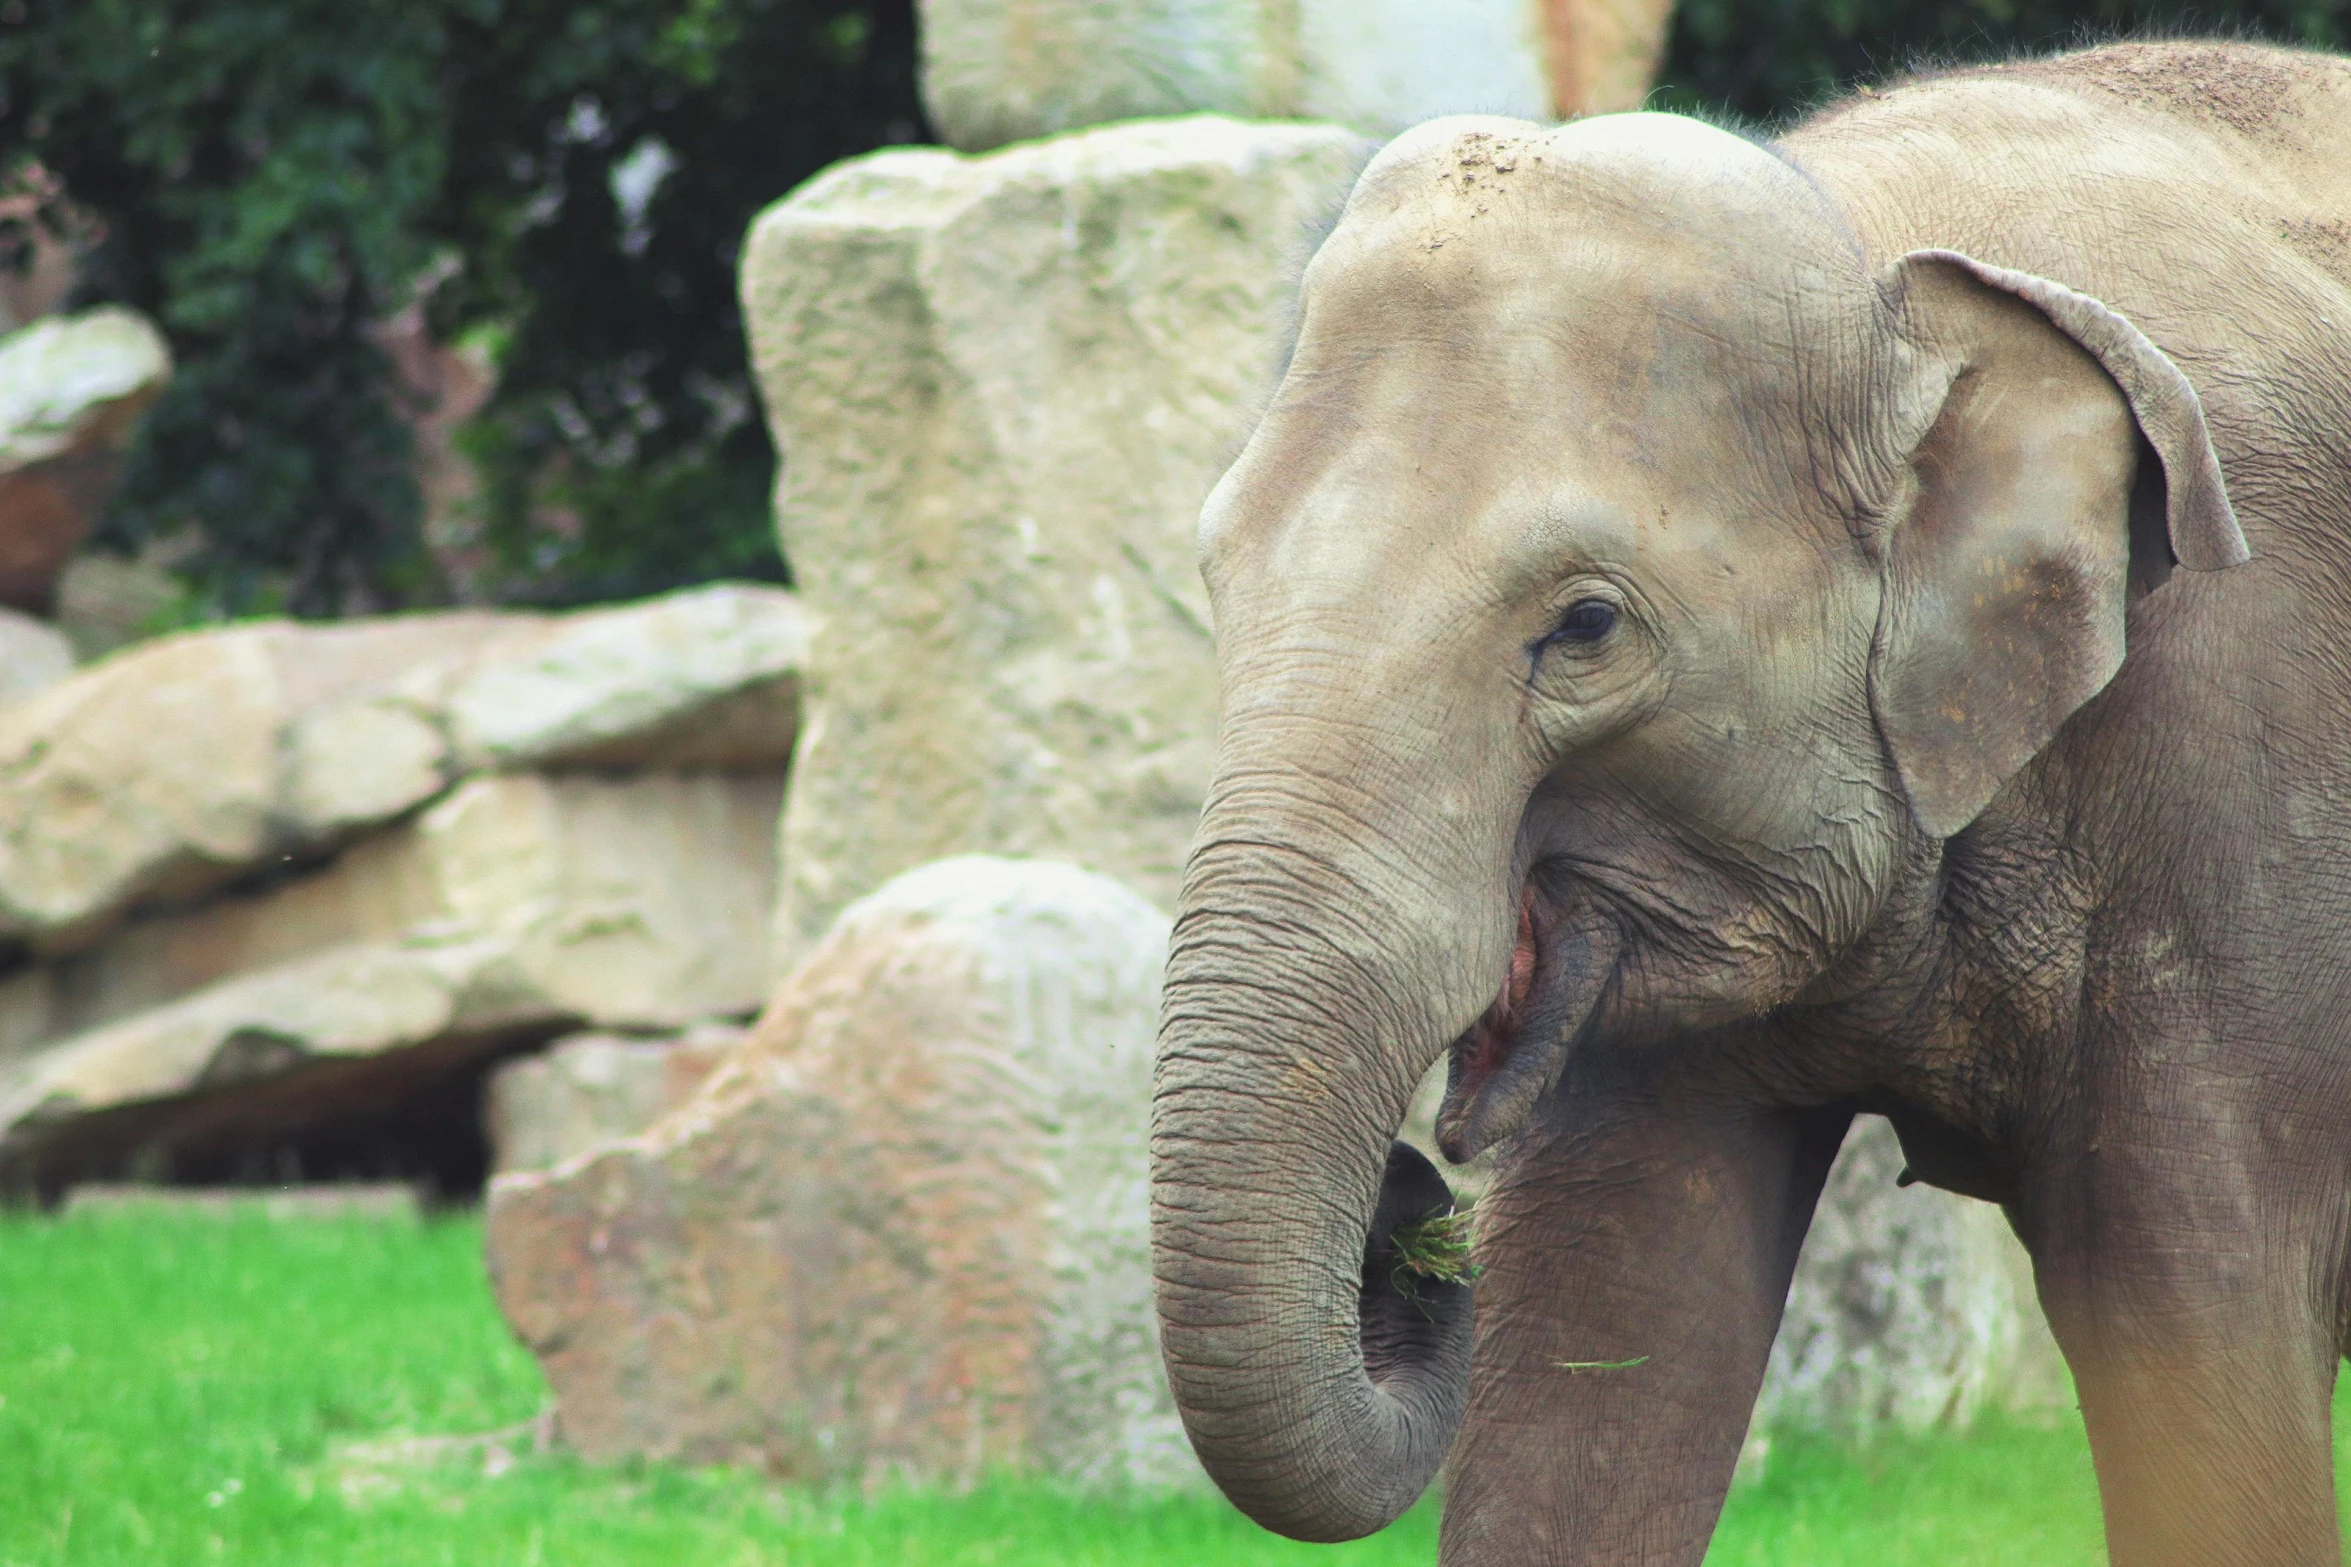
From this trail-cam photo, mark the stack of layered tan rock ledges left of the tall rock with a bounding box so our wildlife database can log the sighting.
[0,587,804,1193]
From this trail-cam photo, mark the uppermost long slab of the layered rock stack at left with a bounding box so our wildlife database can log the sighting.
[0,585,806,951]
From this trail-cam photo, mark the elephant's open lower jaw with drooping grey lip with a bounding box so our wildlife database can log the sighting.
[1436,886,1617,1165]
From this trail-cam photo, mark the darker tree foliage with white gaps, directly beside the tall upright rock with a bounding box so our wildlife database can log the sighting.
[433,0,924,599]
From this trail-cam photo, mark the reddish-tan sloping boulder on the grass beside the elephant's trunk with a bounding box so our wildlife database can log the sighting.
[489,855,1197,1485]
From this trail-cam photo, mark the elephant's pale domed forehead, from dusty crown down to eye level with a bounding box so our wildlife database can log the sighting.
[1201,115,1874,616]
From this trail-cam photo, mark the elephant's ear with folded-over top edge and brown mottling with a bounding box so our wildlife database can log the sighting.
[1869,251,2250,836]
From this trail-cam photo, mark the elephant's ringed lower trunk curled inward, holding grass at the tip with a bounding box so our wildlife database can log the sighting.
[1152,831,1507,1541]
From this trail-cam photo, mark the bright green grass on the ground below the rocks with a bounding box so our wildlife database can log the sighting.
[0,1212,2332,1567]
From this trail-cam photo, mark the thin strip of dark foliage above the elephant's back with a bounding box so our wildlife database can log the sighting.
[1660,0,2351,122]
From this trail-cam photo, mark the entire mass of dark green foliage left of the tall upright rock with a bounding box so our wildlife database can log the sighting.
[0,0,922,616]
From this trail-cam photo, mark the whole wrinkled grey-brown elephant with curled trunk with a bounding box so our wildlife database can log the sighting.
[1152,45,2351,1567]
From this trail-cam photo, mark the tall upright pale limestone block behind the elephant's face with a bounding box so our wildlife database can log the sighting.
[743,117,1368,961]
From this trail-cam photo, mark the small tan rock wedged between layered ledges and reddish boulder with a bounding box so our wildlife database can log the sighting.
[484,1024,745,1175]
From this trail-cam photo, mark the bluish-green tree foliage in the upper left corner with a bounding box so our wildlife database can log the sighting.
[0,0,444,613]
